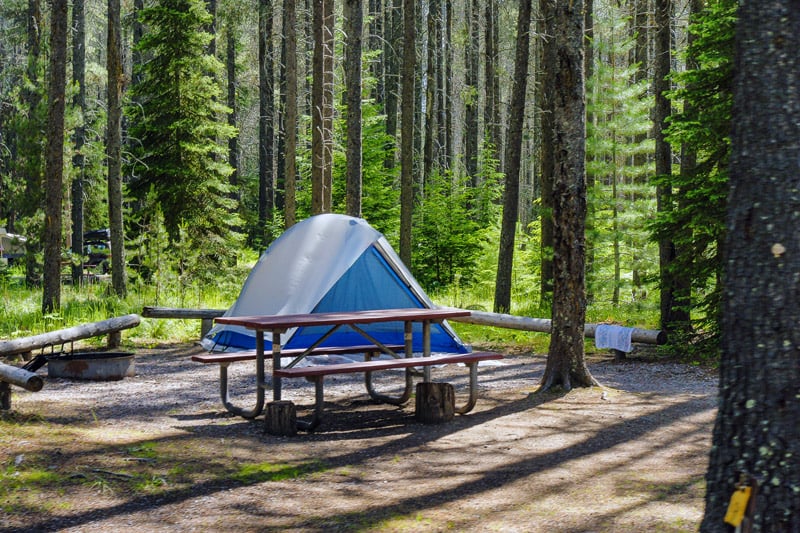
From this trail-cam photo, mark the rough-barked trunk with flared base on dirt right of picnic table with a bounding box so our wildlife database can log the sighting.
[541,0,597,391]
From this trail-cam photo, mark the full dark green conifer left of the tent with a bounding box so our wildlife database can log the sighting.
[127,0,238,256]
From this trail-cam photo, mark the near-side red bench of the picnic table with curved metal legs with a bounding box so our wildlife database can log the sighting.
[272,352,503,431]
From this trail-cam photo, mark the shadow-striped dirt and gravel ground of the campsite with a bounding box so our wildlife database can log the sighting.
[0,344,716,532]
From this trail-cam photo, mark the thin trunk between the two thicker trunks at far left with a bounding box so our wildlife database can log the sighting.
[71,0,86,286]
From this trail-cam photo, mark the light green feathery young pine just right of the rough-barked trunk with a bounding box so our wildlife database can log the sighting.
[586,10,656,305]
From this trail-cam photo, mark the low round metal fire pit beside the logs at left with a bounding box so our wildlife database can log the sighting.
[47,352,136,381]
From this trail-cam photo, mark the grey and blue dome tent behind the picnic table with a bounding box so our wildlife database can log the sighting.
[203,214,469,353]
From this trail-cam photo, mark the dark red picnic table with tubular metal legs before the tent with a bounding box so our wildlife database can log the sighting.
[209,308,502,429]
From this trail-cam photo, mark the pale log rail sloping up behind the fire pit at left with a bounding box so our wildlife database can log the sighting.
[0,314,141,356]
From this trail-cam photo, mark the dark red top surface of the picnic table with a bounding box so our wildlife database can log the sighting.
[215,307,470,331]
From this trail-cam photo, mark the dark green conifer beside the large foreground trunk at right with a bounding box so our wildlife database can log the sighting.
[650,0,737,353]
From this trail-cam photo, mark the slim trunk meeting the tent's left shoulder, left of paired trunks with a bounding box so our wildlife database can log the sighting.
[283,0,297,228]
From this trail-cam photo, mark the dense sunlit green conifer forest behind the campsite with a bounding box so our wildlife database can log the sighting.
[0,0,735,359]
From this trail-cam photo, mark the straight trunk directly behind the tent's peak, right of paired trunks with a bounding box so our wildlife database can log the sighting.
[344,0,364,217]
